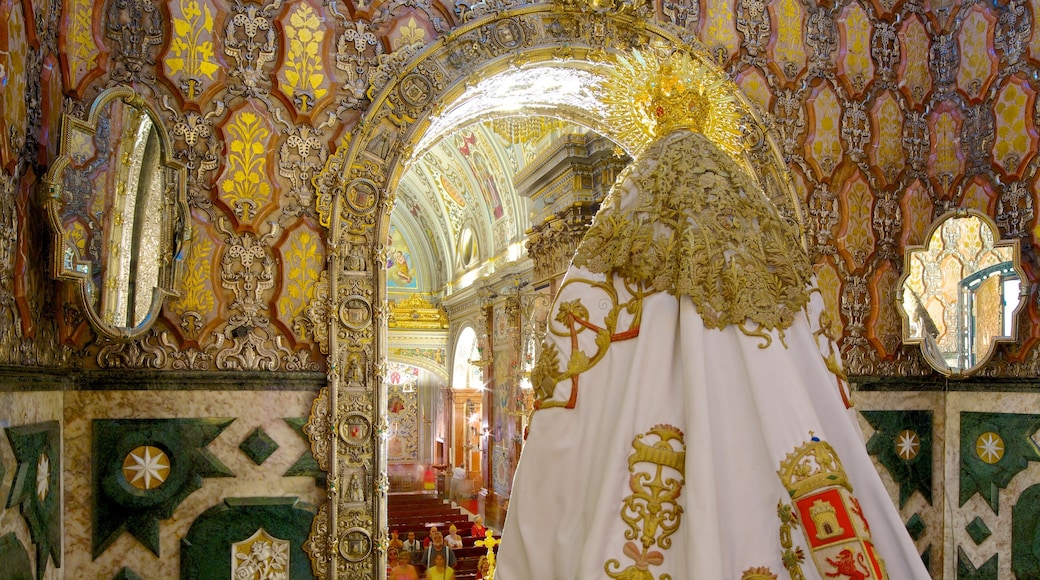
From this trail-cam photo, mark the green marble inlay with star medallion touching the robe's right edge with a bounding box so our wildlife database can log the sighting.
[862,411,933,508]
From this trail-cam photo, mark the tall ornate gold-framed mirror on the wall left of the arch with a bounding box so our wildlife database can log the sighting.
[45,87,190,340]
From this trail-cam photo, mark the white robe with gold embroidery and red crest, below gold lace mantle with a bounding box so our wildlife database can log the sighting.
[495,128,929,580]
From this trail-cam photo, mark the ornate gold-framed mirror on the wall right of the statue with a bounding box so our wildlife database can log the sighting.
[898,210,1028,376]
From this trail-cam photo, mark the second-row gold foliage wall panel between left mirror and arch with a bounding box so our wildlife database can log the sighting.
[218,110,274,223]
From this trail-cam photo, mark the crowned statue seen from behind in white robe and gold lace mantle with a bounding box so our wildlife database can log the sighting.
[495,53,929,580]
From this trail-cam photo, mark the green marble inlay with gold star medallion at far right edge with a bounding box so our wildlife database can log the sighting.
[960,413,1040,513]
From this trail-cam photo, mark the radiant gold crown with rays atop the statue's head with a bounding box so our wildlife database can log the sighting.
[597,50,744,160]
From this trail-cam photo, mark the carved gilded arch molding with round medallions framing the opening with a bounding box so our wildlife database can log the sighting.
[305,2,786,578]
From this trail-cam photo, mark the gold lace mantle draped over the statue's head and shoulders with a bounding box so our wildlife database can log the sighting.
[573,130,810,348]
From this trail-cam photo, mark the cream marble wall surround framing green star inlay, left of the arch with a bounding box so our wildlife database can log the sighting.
[64,391,323,578]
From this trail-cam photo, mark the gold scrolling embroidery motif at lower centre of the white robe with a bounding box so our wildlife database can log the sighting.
[603,425,686,580]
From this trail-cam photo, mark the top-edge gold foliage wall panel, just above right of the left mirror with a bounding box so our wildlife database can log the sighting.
[163,0,219,101]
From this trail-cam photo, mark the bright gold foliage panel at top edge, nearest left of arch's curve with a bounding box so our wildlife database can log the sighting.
[279,2,328,112]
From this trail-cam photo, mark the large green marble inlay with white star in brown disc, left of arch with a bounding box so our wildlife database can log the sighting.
[92,418,235,558]
